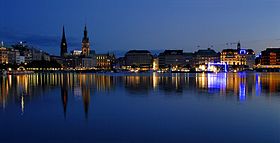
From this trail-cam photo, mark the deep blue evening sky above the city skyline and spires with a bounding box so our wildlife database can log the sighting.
[0,0,280,54]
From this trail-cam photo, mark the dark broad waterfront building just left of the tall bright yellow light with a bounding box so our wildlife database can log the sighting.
[124,50,153,70]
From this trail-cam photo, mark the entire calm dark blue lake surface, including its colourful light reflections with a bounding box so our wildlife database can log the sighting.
[0,73,280,143]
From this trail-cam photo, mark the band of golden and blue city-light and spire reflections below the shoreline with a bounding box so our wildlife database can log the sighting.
[0,73,280,115]
